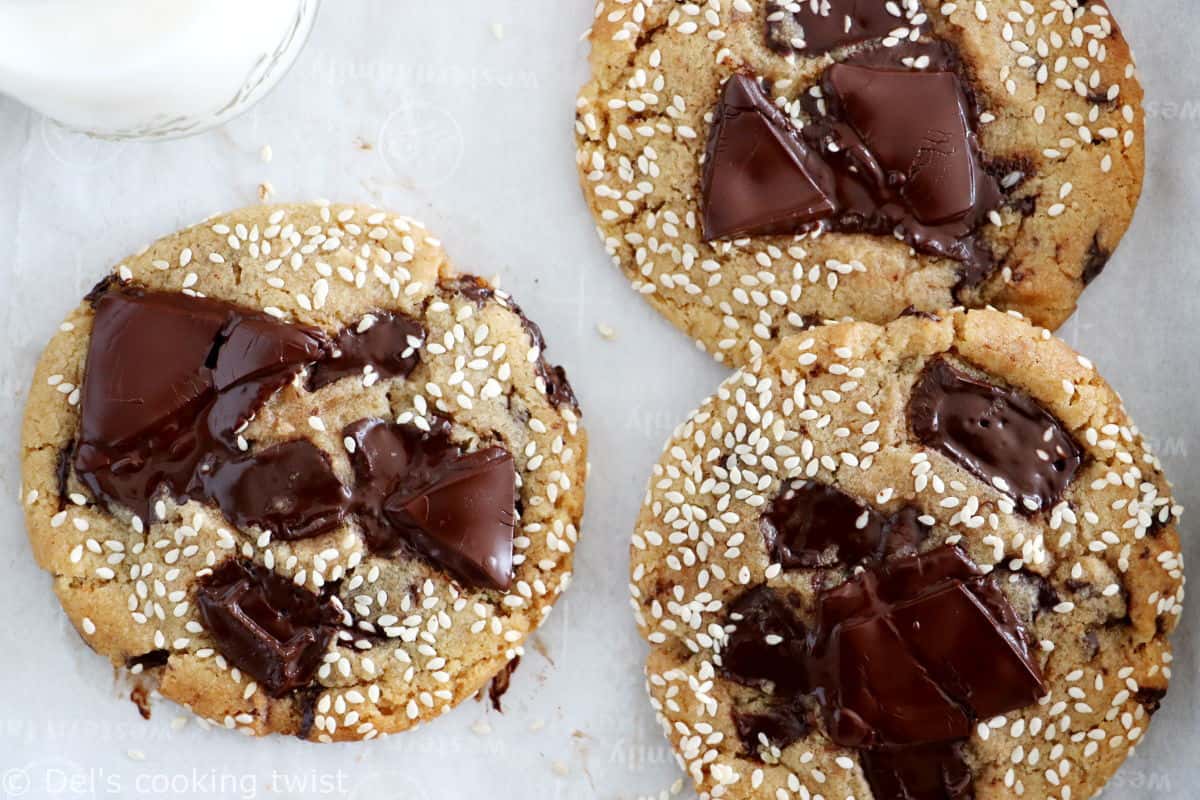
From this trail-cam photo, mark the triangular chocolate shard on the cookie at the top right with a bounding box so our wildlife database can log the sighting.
[701,74,835,241]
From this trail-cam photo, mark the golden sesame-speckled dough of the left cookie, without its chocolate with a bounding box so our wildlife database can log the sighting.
[22,204,587,741]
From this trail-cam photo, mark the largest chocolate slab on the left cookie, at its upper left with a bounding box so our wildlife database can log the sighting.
[74,289,324,522]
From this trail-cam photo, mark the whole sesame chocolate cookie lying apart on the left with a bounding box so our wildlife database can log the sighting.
[23,205,587,741]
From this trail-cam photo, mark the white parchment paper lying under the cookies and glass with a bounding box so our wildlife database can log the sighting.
[0,0,1200,800]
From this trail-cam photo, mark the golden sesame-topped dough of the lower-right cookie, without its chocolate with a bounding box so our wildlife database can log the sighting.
[630,311,1183,800]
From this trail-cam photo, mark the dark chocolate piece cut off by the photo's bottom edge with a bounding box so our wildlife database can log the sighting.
[863,742,976,800]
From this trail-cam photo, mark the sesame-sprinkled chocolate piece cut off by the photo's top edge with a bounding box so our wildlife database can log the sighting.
[767,0,925,55]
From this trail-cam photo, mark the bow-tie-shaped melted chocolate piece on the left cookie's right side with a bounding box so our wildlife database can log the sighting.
[346,420,516,589]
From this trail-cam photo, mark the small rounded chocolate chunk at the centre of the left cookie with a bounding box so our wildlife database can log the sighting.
[200,440,349,541]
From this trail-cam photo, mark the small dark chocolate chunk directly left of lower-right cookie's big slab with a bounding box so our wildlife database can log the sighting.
[721,585,809,692]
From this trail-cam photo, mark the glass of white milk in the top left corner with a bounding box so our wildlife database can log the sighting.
[0,0,319,139]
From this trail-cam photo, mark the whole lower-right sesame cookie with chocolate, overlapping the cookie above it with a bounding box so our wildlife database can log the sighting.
[630,311,1183,800]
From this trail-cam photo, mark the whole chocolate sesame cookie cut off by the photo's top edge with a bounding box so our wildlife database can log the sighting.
[576,0,1144,366]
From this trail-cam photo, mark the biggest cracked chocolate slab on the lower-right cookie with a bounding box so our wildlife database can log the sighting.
[812,547,1046,747]
